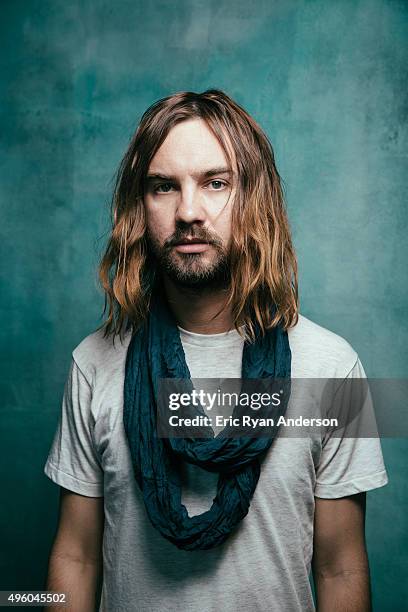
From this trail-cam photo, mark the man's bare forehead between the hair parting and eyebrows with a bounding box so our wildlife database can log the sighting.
[148,118,234,175]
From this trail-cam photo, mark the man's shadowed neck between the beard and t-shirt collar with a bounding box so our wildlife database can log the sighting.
[163,277,234,334]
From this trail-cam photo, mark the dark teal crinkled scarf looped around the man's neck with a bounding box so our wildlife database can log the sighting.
[123,293,291,550]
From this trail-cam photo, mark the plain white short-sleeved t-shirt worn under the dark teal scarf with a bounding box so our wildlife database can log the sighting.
[44,316,388,612]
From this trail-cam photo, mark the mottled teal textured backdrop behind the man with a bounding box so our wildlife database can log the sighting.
[0,0,408,612]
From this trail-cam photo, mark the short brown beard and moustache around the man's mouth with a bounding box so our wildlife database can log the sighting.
[147,226,231,291]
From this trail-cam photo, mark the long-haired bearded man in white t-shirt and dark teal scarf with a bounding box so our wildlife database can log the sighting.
[45,90,387,612]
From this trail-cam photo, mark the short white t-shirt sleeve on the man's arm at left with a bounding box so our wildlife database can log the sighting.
[44,357,103,497]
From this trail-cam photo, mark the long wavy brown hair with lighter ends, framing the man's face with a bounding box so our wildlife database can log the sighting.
[98,89,299,341]
